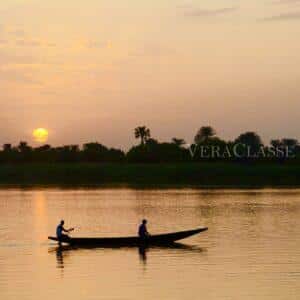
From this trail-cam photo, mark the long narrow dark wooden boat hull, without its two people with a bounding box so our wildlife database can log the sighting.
[48,227,208,247]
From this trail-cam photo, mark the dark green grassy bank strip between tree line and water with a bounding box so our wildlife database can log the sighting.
[0,162,300,187]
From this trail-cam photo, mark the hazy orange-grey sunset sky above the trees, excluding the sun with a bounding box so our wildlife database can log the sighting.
[0,0,300,149]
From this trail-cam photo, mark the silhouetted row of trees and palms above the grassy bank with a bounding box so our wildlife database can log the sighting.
[0,126,300,163]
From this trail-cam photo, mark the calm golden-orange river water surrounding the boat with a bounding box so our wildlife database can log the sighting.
[0,188,300,300]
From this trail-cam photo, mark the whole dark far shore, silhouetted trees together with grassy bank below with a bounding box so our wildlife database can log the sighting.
[0,126,300,187]
